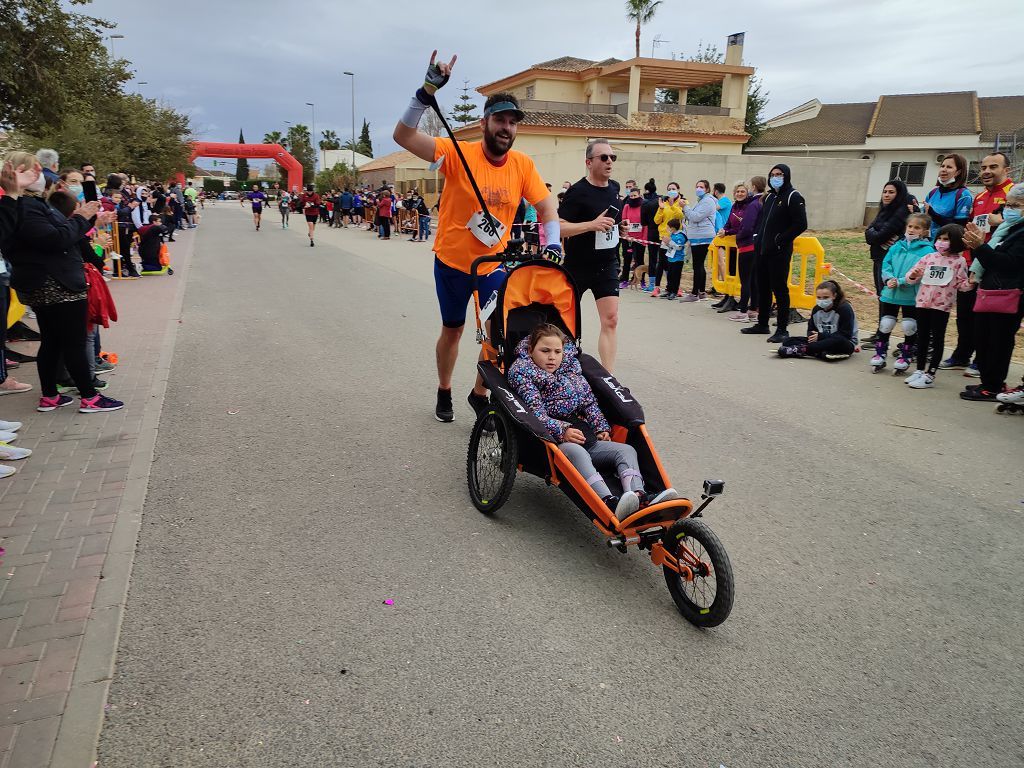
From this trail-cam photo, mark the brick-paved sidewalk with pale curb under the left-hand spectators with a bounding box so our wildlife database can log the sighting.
[0,230,195,768]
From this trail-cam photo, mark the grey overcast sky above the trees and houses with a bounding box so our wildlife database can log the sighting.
[75,0,1024,166]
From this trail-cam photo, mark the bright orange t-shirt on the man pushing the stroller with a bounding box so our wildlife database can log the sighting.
[434,138,550,274]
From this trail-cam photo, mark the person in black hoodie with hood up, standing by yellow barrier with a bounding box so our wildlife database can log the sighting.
[739,163,807,344]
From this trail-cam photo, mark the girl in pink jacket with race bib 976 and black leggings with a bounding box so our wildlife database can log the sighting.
[905,224,971,389]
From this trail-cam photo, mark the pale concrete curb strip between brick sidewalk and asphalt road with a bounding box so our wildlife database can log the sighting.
[50,238,196,768]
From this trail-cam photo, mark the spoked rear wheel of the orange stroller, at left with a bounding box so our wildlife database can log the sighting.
[466,406,519,514]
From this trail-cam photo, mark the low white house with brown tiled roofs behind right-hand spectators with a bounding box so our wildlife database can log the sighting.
[746,91,1024,218]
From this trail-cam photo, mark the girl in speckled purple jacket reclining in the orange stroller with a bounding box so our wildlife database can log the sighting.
[508,324,679,520]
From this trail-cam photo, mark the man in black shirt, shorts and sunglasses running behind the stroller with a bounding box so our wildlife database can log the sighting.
[558,139,622,371]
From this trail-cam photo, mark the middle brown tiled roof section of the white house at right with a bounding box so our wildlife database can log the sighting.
[869,91,978,136]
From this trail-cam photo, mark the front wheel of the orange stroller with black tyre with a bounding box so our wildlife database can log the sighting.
[662,518,733,627]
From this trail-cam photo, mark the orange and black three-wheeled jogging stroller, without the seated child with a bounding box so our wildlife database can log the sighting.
[466,249,733,627]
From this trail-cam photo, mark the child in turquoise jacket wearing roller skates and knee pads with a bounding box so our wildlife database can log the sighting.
[871,213,935,371]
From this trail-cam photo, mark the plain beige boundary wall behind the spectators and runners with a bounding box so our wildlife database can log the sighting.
[528,151,870,230]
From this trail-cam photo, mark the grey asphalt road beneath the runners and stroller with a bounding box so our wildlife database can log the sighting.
[99,204,1024,768]
